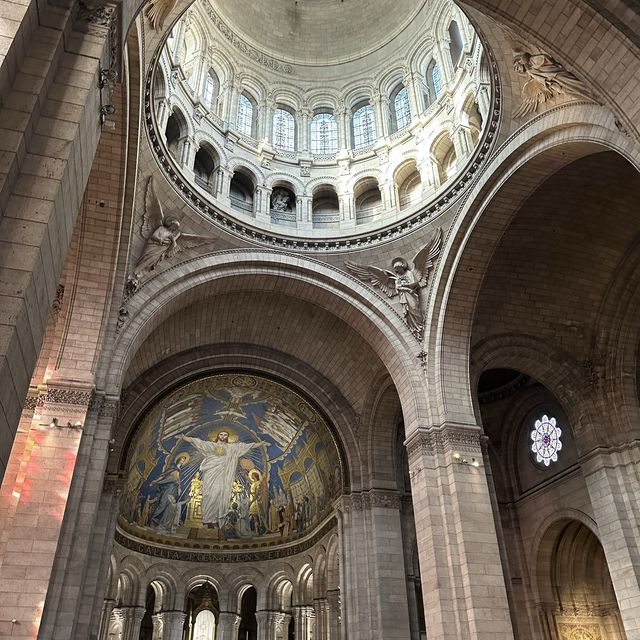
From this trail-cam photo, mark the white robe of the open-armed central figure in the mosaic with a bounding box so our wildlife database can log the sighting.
[185,437,256,527]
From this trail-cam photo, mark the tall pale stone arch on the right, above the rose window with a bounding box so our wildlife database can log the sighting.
[426,104,638,432]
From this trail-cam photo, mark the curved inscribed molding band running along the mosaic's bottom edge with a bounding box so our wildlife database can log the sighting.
[115,517,337,563]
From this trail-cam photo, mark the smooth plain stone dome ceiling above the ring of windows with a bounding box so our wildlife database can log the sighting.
[209,0,426,65]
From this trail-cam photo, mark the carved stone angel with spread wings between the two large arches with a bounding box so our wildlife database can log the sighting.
[345,229,442,339]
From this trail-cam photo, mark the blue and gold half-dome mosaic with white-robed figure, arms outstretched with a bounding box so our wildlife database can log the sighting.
[119,374,342,546]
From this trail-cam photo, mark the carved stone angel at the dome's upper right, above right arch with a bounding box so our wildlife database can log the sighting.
[513,51,593,118]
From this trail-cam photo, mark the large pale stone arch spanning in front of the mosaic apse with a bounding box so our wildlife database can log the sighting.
[105,250,426,426]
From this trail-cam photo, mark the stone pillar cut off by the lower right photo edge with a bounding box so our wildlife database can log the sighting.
[582,444,640,639]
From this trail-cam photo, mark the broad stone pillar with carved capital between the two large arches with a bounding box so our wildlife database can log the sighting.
[406,425,513,640]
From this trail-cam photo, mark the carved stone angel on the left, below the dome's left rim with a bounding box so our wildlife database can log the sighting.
[129,177,213,283]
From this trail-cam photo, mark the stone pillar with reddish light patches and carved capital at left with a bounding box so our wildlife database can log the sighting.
[0,381,92,638]
